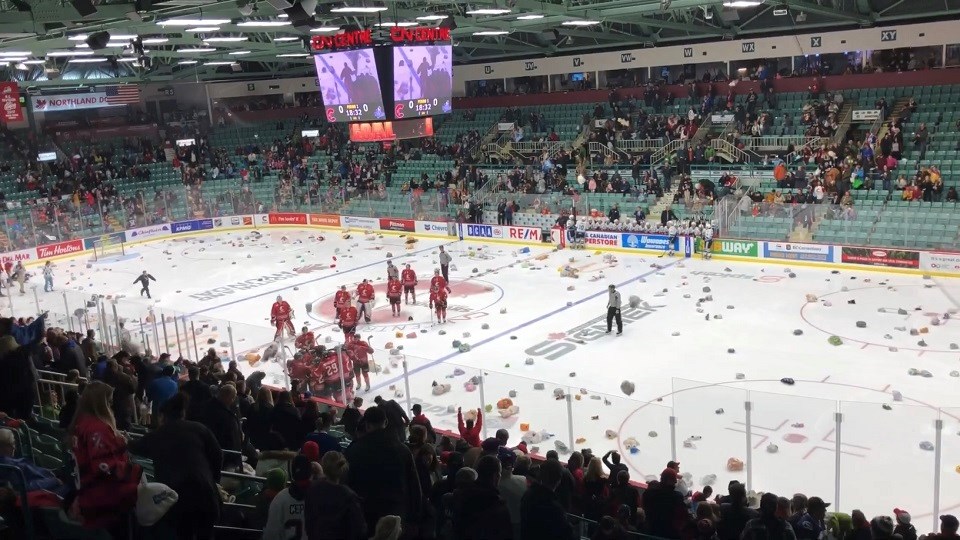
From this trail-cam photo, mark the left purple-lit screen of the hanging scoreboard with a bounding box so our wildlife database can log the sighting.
[313,49,387,122]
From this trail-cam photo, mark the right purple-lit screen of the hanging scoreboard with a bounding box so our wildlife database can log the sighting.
[393,45,453,119]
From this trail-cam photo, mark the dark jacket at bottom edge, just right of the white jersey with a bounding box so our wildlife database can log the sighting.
[303,480,367,540]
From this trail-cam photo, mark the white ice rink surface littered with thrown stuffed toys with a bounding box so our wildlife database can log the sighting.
[12,229,960,524]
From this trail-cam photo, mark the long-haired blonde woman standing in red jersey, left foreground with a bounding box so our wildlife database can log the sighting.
[68,381,142,538]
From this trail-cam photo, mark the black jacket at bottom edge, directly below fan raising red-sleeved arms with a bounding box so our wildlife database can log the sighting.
[451,482,513,540]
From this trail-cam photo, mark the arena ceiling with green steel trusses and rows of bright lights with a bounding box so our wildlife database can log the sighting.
[0,0,960,86]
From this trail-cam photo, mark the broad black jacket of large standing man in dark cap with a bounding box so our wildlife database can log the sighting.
[344,429,421,530]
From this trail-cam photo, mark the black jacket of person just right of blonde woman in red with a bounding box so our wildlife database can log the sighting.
[130,420,223,518]
